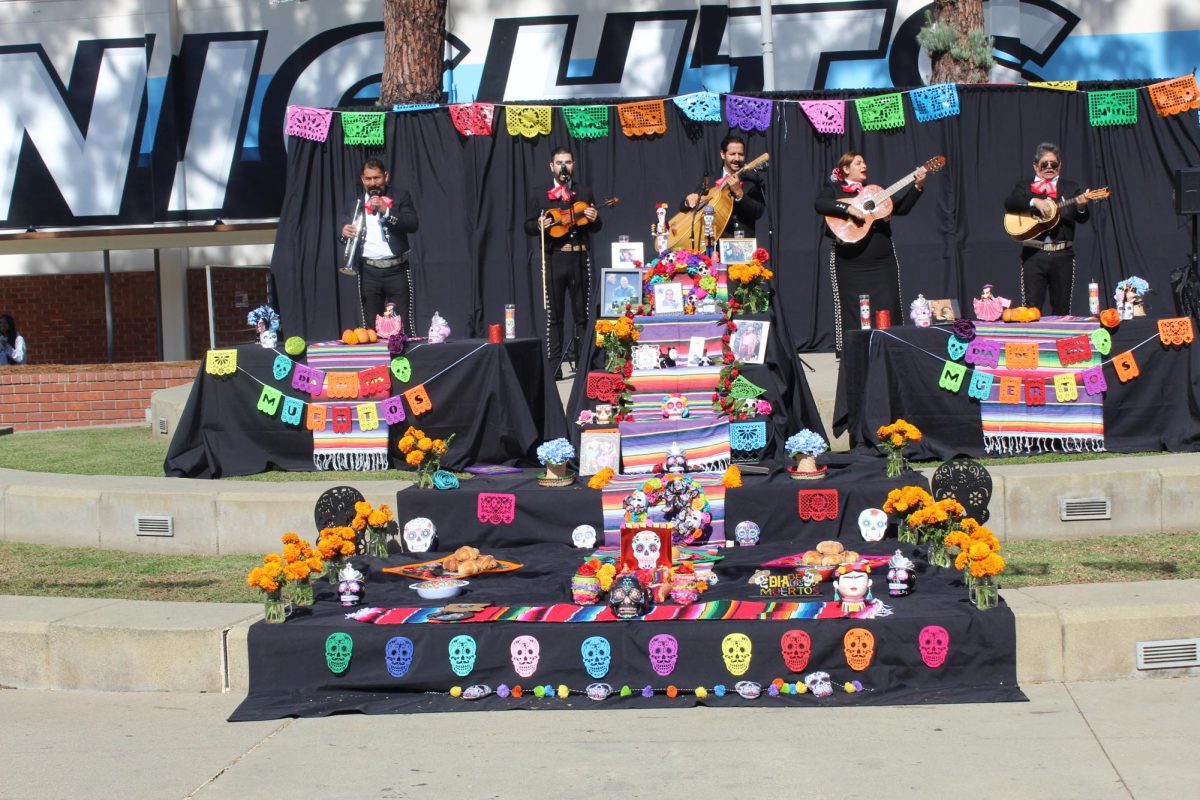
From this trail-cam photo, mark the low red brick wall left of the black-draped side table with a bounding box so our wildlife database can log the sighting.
[0,361,199,431]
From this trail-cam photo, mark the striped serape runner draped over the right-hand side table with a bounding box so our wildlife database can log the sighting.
[964,317,1104,455]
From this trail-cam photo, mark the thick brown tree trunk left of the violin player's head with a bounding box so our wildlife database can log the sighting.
[379,0,446,106]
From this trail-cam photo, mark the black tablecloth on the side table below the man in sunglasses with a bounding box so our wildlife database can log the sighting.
[834,318,1200,459]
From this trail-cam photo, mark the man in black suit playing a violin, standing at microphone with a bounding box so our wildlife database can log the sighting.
[524,148,602,380]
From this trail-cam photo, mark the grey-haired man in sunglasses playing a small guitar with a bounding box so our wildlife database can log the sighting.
[1004,142,1088,315]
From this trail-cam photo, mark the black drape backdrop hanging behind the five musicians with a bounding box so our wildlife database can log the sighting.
[271,84,1200,349]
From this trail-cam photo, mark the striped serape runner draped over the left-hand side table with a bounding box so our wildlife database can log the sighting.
[306,342,391,470]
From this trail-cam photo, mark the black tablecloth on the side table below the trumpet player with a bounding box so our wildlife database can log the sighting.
[163,339,568,477]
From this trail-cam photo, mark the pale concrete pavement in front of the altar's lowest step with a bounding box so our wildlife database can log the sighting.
[0,678,1200,800]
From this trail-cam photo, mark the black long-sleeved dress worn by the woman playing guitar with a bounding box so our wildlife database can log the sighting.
[814,181,922,351]
